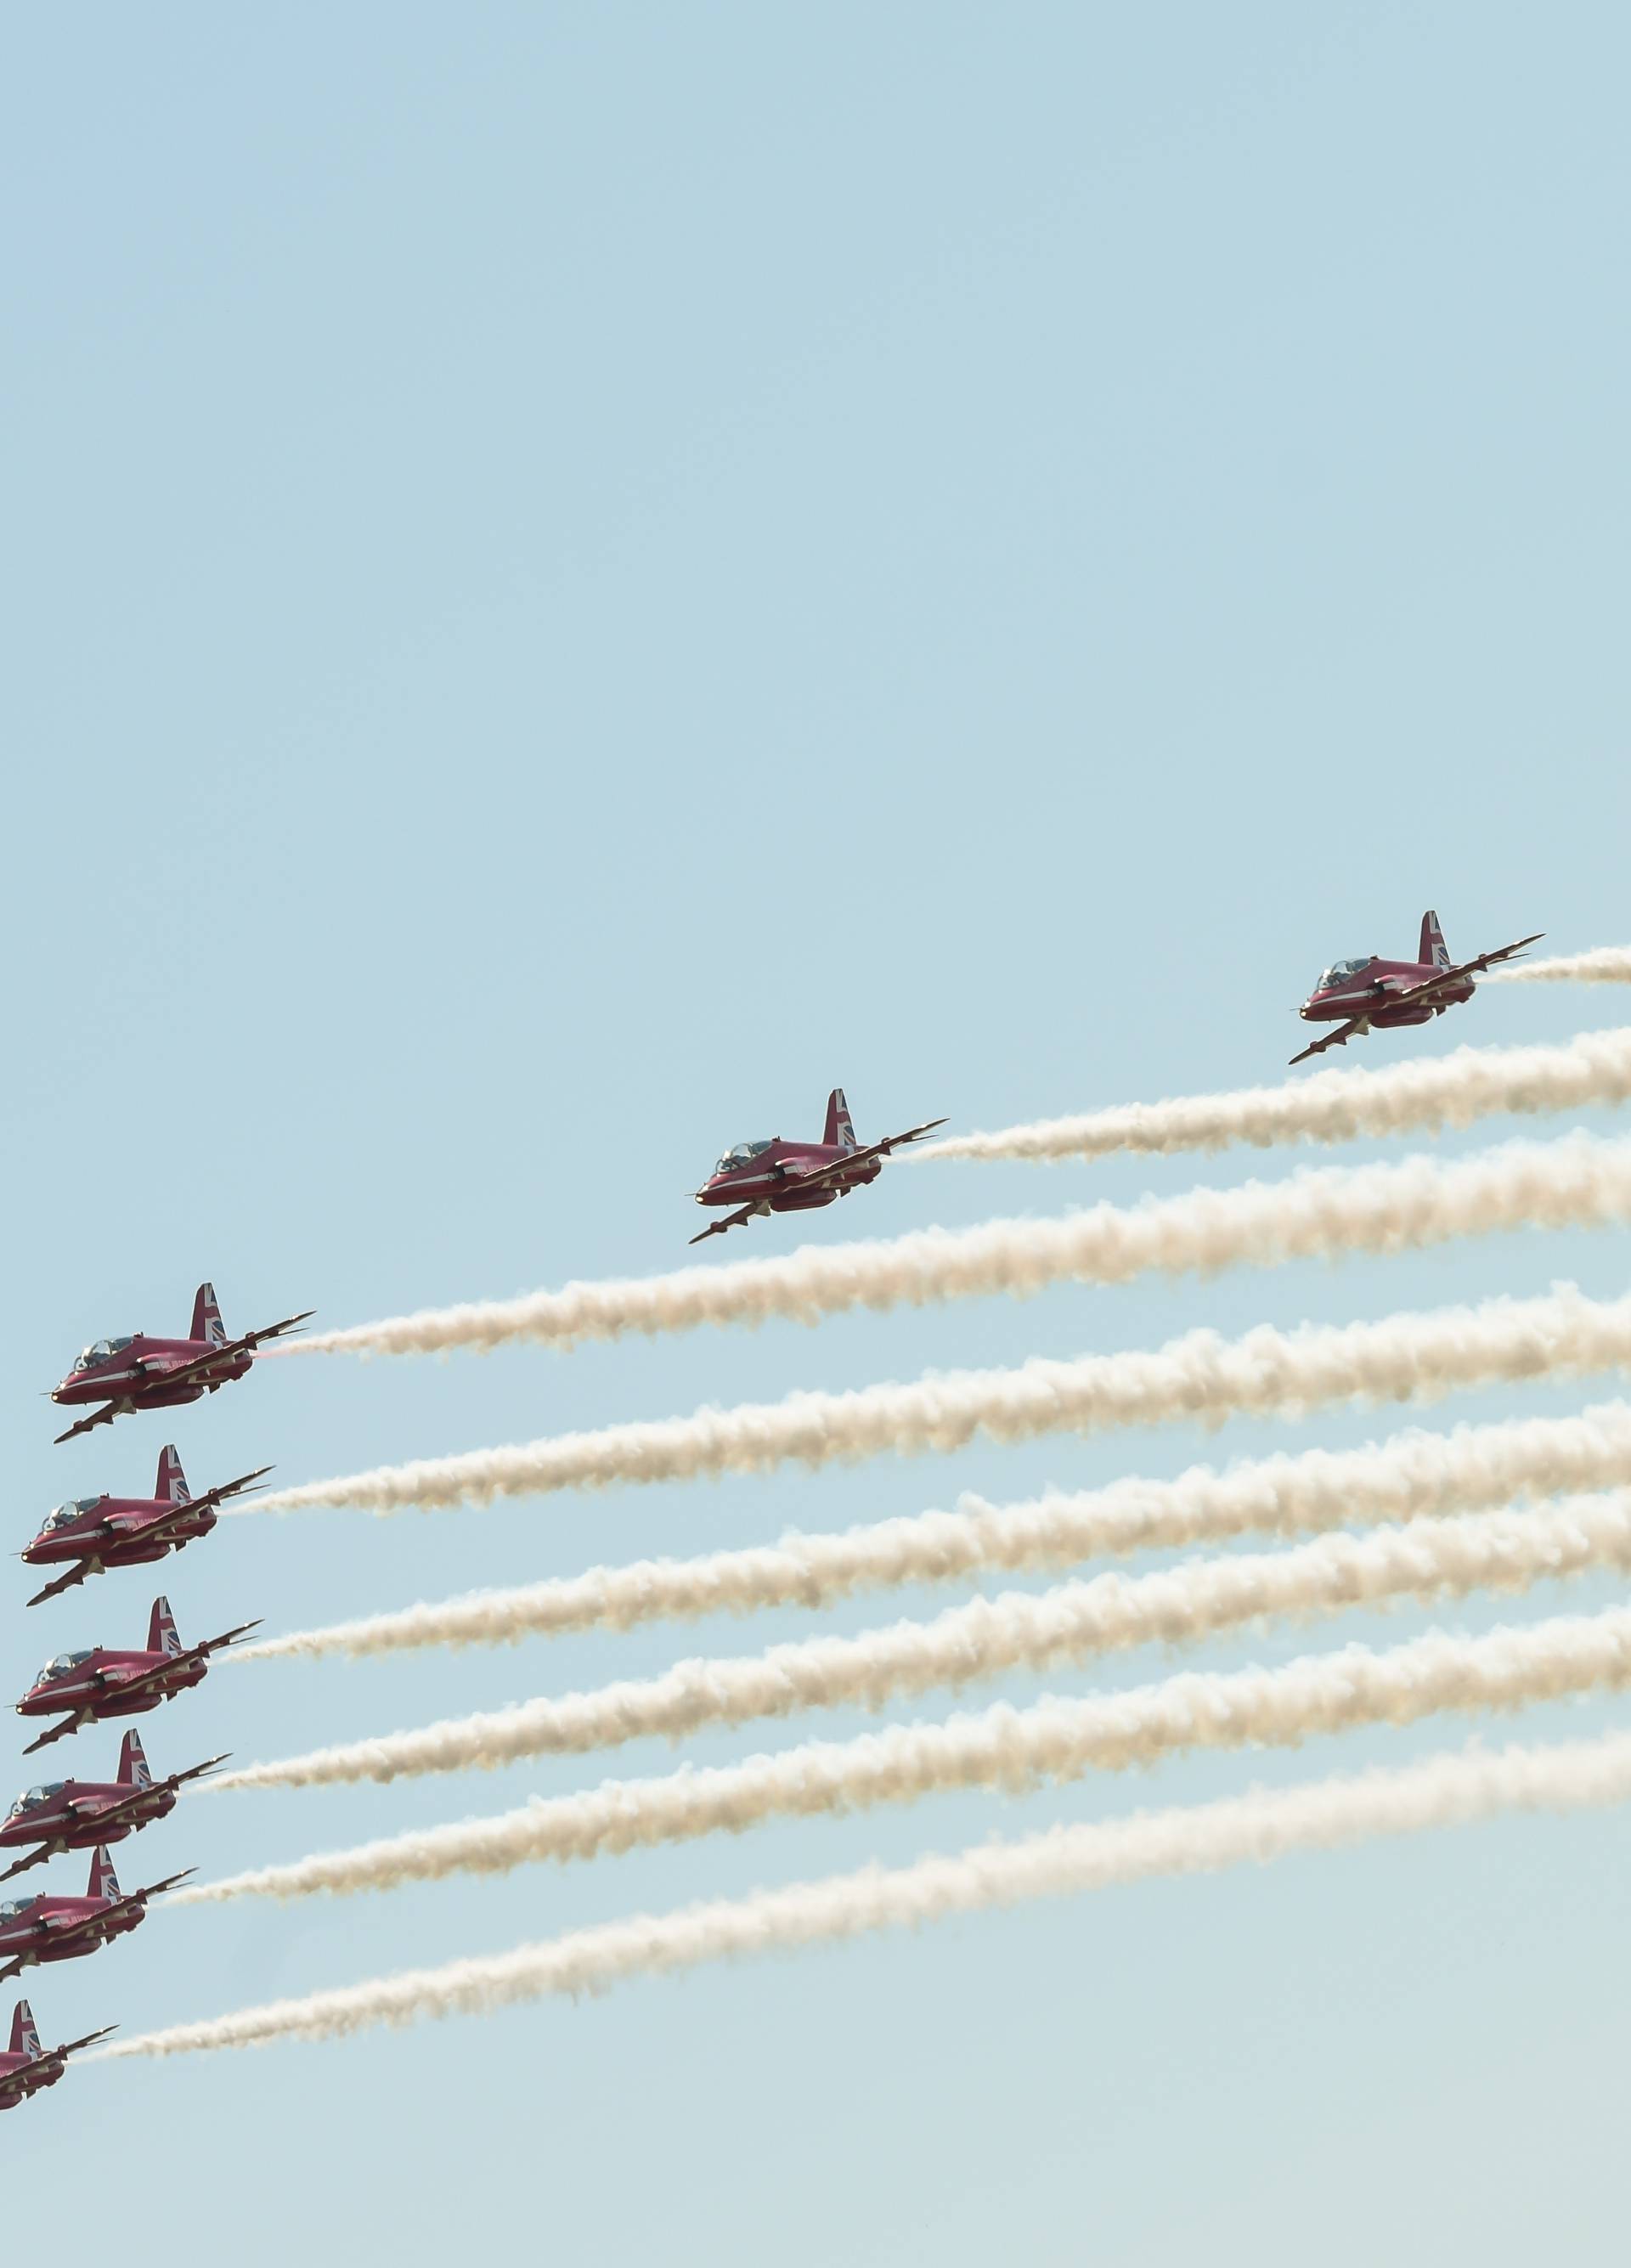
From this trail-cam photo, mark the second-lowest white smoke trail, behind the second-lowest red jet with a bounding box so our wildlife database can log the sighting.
[191,1608,1631,1905]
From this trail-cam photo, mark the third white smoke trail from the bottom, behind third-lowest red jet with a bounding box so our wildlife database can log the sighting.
[216,1490,1631,1787]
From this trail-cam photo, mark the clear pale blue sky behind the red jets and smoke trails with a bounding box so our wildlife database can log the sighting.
[0,4,1631,2268]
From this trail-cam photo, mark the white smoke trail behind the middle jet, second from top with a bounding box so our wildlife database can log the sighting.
[910,1034,1631,1165]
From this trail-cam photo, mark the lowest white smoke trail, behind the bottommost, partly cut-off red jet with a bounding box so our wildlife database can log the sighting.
[99,1733,1631,2062]
